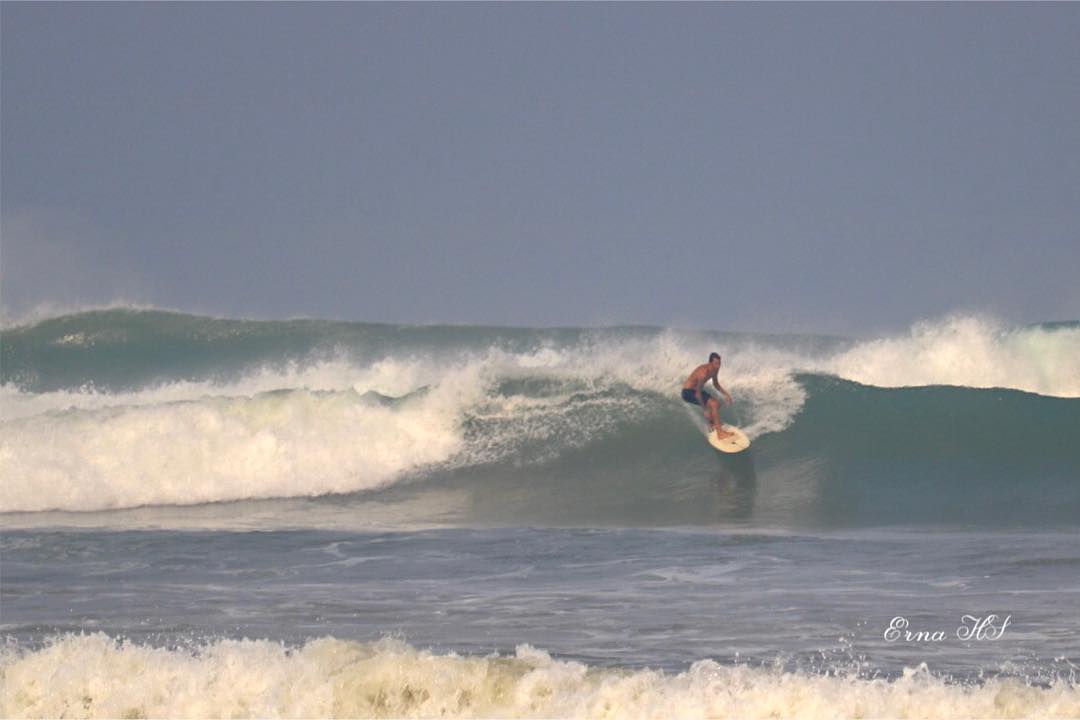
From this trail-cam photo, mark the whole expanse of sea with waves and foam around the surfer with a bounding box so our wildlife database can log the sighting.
[0,309,1080,718]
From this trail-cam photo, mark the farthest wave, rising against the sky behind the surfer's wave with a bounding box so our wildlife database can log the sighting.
[0,309,1080,397]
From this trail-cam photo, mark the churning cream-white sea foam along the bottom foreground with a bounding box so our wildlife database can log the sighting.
[0,634,1080,719]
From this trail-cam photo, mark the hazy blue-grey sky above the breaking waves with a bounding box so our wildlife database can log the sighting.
[0,2,1080,335]
